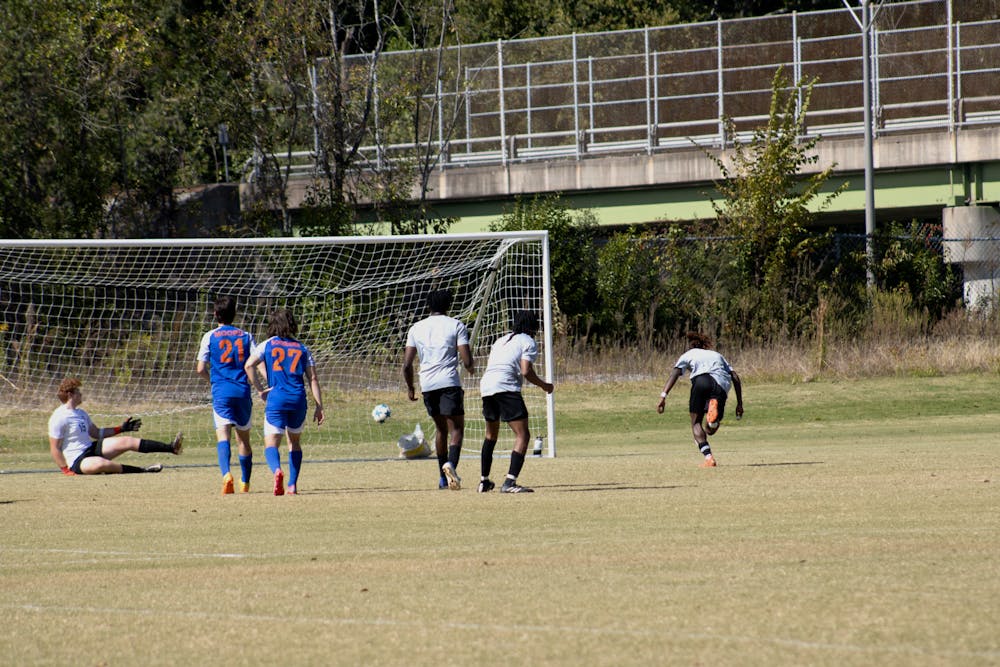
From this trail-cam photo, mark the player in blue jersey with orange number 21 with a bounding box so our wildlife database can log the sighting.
[197,296,255,495]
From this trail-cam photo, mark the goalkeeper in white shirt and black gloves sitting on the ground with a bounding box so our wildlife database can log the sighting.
[49,378,183,475]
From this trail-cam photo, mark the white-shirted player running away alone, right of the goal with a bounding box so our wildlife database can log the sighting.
[656,331,743,468]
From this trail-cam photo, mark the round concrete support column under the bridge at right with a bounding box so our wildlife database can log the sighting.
[942,206,1000,310]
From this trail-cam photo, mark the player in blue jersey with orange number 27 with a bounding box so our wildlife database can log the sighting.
[246,308,324,496]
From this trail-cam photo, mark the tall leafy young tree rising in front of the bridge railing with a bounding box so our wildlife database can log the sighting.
[708,69,846,338]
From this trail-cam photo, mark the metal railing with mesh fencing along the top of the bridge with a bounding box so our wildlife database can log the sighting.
[250,0,1000,181]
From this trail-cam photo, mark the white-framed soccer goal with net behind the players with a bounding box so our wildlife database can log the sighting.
[0,232,555,458]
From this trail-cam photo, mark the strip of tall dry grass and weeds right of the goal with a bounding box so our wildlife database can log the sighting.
[554,293,1000,382]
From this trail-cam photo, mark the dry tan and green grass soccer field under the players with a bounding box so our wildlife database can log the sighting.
[0,375,1000,666]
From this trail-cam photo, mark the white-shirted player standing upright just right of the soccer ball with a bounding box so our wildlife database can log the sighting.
[403,290,475,490]
